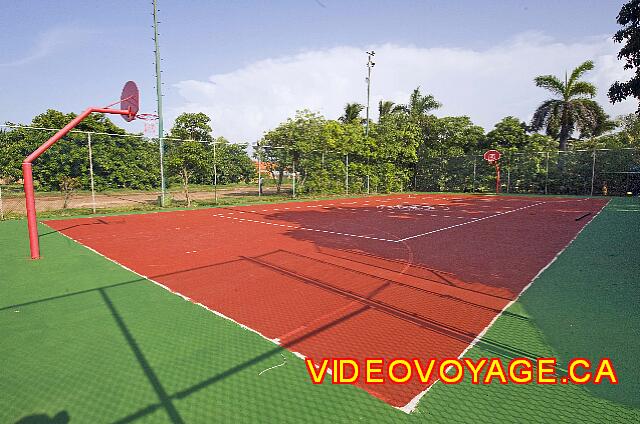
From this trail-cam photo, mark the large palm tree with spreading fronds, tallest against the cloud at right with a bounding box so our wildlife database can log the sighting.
[531,60,606,150]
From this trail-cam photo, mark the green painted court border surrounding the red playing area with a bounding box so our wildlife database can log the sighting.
[0,199,640,423]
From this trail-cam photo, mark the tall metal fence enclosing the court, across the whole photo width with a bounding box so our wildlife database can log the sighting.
[0,123,640,219]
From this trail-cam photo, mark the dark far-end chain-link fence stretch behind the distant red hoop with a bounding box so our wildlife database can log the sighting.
[414,148,640,196]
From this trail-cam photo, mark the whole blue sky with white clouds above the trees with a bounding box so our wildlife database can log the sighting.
[0,0,637,143]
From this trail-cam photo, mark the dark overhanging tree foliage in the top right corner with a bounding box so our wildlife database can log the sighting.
[608,0,640,114]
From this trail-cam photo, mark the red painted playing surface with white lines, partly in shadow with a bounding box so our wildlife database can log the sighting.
[46,195,606,409]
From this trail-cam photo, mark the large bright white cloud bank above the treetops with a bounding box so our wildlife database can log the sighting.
[169,33,637,142]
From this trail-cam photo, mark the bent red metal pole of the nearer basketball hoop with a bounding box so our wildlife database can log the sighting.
[22,107,135,259]
